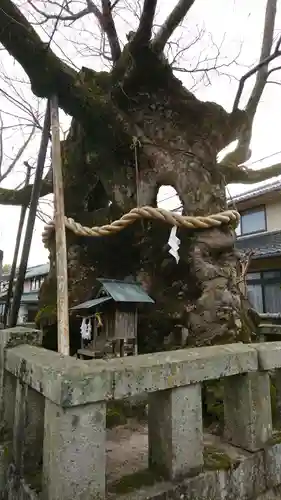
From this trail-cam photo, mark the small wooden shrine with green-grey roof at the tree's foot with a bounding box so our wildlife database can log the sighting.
[71,279,154,359]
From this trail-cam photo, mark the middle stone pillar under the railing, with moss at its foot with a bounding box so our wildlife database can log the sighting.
[148,384,203,479]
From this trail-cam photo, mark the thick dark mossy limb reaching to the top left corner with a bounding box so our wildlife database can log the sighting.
[0,0,122,135]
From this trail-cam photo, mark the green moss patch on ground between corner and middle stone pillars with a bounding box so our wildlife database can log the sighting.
[109,469,164,495]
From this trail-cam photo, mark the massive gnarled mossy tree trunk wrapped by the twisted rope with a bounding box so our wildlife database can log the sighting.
[38,48,247,351]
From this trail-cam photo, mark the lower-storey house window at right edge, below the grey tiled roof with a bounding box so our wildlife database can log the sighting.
[247,270,281,313]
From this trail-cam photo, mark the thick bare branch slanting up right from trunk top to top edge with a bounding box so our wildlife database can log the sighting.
[152,0,195,52]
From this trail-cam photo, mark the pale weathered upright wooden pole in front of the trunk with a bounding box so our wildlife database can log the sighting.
[51,96,69,356]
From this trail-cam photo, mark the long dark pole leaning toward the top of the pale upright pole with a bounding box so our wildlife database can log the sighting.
[9,102,50,327]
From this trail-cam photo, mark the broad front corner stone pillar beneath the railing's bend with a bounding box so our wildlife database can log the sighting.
[42,400,106,500]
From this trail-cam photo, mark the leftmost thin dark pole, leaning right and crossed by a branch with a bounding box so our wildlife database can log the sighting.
[3,163,31,328]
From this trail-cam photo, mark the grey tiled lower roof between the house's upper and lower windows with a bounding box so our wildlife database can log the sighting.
[235,231,281,259]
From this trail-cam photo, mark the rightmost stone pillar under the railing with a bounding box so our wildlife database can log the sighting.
[224,372,272,451]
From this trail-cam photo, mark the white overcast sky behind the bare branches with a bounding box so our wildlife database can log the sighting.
[0,0,281,265]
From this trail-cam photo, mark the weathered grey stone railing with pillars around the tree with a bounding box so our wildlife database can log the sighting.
[0,328,281,500]
